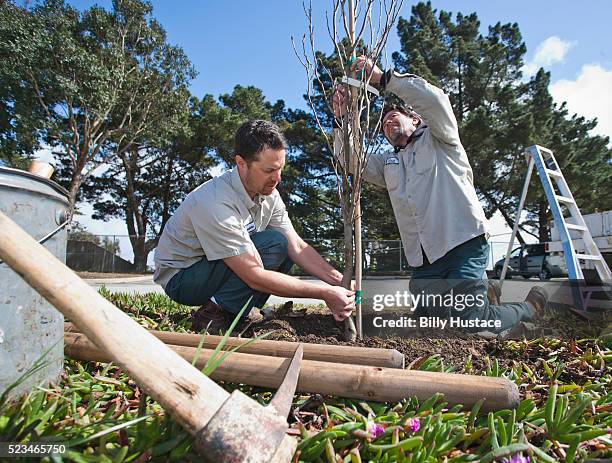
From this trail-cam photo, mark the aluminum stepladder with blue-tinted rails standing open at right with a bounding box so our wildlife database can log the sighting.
[500,145,612,310]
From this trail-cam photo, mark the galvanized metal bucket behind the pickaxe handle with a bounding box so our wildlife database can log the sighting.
[0,167,70,397]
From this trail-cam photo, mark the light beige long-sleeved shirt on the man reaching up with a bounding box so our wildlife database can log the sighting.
[335,73,488,267]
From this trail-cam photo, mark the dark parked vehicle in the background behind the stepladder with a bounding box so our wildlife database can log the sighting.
[494,243,567,280]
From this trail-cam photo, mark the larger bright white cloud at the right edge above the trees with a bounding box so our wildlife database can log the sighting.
[550,64,612,138]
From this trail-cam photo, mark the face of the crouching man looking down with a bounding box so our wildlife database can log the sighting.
[236,148,285,197]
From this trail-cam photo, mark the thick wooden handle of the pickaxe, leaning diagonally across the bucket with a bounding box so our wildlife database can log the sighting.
[0,212,229,434]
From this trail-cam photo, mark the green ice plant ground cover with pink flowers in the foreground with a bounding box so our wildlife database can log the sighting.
[0,290,612,463]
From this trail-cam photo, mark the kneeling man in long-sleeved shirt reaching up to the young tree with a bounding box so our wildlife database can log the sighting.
[333,56,548,337]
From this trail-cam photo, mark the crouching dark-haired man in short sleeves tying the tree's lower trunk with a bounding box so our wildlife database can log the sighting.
[154,120,355,332]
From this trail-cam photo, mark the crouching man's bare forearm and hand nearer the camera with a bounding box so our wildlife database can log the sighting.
[223,250,355,321]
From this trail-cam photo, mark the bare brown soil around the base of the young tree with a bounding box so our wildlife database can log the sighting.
[243,307,599,384]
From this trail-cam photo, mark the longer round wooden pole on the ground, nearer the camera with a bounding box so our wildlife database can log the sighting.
[64,333,520,410]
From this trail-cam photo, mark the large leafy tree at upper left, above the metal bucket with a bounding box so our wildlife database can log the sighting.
[0,0,195,207]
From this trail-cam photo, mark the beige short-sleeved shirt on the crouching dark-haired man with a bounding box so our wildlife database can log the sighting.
[153,168,293,287]
